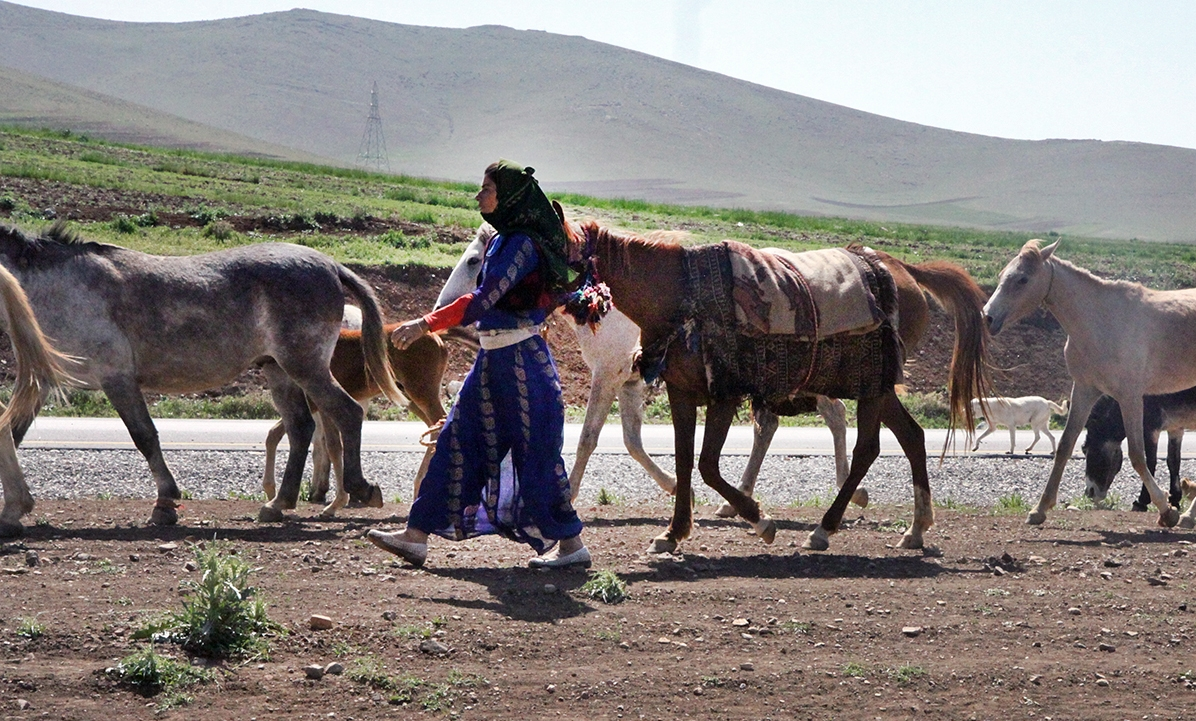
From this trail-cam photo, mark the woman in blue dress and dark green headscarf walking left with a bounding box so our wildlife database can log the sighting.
[367,160,591,568]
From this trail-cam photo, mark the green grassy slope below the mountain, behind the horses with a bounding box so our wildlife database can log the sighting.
[7,129,1196,424]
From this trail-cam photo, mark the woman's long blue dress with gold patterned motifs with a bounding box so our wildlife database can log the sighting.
[408,230,581,552]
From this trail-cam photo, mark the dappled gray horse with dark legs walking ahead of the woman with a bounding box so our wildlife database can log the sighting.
[0,224,399,525]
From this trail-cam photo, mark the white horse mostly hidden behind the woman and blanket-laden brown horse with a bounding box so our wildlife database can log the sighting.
[437,224,868,518]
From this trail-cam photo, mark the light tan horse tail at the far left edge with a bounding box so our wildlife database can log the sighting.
[0,265,74,433]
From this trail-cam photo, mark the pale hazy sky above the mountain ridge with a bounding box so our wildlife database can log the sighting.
[19,0,1196,148]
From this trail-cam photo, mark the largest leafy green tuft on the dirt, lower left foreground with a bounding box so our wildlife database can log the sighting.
[133,543,282,658]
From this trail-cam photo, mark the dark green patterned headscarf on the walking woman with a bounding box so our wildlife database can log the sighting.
[482,160,576,295]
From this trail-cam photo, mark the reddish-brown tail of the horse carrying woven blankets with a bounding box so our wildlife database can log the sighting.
[892,258,993,452]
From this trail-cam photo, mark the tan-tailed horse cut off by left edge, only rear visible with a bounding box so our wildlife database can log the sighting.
[0,265,74,538]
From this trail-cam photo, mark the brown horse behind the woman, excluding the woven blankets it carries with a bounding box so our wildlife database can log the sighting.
[569,221,988,552]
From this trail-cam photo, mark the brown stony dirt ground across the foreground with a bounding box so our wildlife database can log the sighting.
[0,500,1196,721]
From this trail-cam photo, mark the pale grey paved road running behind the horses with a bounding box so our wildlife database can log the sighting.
[16,417,1119,458]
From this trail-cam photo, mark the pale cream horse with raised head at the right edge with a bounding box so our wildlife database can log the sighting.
[984,240,1196,528]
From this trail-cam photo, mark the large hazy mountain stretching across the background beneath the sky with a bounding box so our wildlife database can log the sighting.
[0,2,1196,242]
